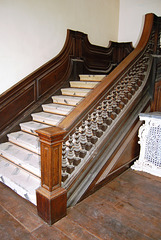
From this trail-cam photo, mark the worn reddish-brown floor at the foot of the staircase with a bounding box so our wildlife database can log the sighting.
[0,170,161,240]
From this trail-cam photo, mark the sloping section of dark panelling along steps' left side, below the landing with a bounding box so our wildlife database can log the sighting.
[0,34,72,135]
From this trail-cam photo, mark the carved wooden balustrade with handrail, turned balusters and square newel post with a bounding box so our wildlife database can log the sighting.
[37,14,161,223]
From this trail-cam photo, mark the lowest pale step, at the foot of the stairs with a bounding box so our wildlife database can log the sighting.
[0,157,41,205]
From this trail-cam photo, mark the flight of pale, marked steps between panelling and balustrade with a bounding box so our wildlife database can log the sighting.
[0,75,105,205]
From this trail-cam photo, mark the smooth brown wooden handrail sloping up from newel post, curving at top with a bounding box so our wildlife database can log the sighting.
[59,14,154,132]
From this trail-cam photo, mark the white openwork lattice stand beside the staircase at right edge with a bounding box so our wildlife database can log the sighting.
[131,112,161,177]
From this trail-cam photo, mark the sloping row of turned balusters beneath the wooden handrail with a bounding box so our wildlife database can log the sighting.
[62,48,151,188]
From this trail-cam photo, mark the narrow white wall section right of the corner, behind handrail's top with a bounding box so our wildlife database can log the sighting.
[118,0,161,46]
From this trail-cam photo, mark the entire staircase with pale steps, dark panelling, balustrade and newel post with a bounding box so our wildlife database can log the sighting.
[0,14,161,224]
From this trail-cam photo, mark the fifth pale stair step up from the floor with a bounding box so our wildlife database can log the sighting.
[31,112,64,126]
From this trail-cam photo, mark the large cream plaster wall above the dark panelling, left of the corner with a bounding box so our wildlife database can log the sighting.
[0,0,119,94]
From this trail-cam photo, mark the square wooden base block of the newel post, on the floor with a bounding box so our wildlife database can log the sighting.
[36,187,67,225]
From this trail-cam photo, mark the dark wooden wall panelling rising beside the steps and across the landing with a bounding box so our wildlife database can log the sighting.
[0,30,132,140]
